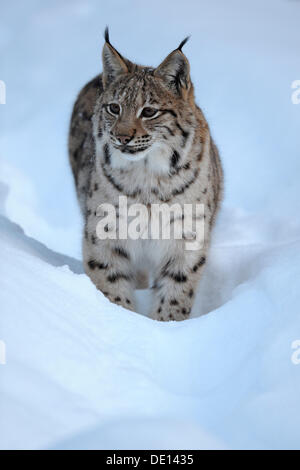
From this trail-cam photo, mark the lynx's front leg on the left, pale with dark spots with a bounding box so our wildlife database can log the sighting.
[83,240,135,311]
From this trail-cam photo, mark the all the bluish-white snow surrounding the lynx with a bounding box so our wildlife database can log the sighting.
[0,0,300,449]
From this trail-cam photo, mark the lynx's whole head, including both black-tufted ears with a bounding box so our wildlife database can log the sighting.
[94,29,196,165]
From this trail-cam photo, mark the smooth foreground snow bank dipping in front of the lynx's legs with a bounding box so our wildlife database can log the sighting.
[0,201,300,448]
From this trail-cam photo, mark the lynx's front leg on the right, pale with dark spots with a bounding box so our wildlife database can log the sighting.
[152,246,206,321]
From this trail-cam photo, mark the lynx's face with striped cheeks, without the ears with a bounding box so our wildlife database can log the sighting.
[100,69,189,156]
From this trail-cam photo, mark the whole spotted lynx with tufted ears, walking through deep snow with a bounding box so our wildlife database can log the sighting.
[69,30,223,321]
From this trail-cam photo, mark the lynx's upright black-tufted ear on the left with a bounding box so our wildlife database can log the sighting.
[102,28,131,88]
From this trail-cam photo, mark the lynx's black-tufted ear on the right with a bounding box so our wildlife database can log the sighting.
[154,37,191,96]
